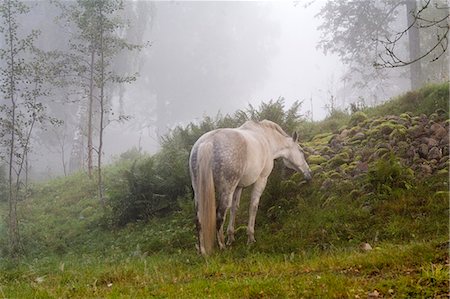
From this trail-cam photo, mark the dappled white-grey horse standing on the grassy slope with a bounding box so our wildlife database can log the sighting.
[189,120,311,255]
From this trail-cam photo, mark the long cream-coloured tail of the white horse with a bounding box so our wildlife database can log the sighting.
[196,142,216,255]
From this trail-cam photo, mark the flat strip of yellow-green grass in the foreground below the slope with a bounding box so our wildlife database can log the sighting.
[0,242,449,298]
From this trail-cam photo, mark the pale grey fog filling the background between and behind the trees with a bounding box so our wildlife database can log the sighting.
[9,0,436,178]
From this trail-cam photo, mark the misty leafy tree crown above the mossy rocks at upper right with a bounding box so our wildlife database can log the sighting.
[318,0,448,95]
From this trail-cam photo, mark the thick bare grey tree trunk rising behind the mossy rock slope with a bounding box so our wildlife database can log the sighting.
[406,0,422,90]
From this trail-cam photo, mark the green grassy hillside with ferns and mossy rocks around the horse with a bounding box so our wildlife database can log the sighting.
[0,83,450,298]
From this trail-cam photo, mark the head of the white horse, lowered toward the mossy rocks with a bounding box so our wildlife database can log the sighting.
[283,132,312,181]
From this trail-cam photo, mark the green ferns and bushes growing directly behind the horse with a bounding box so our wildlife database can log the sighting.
[109,98,302,225]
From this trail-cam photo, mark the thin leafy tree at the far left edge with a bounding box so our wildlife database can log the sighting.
[0,0,55,258]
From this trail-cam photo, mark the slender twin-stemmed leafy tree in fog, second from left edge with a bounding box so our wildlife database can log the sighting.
[55,0,142,204]
